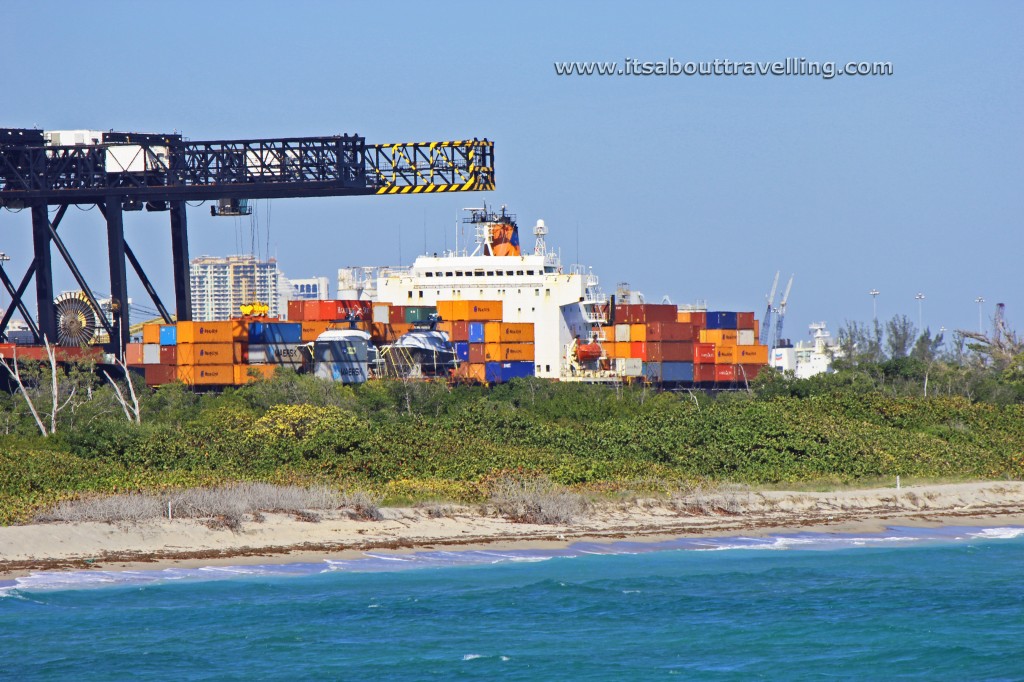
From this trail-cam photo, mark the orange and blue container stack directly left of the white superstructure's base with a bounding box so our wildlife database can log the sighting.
[437,301,535,384]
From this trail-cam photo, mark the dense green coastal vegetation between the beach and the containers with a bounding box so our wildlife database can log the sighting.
[0,315,1024,523]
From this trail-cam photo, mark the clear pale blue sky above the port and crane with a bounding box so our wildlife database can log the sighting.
[0,0,1024,339]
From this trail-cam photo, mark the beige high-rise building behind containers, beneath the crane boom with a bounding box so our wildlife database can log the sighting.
[190,256,287,322]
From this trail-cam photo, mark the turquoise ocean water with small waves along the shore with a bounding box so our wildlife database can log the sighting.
[0,527,1024,680]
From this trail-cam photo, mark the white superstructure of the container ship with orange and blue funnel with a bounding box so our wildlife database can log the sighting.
[375,207,607,378]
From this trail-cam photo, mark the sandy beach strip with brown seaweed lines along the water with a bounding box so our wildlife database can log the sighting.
[0,481,1024,580]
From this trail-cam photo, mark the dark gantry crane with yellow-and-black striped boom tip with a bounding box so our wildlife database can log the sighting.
[0,128,495,354]
